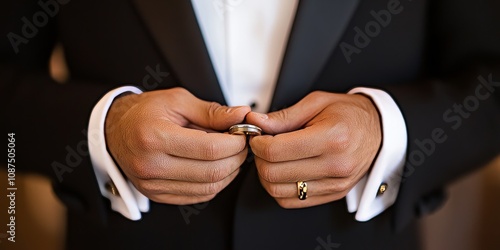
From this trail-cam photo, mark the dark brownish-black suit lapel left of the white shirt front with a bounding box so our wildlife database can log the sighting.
[132,0,225,104]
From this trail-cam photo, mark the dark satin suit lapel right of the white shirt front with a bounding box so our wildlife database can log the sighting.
[271,0,359,111]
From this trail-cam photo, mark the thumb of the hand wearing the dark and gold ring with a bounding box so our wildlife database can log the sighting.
[246,91,334,135]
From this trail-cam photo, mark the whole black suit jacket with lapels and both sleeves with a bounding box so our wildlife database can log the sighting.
[0,0,500,249]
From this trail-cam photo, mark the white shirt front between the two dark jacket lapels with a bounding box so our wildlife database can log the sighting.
[191,0,298,113]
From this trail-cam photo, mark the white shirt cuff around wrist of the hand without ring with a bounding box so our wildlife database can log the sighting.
[88,86,149,220]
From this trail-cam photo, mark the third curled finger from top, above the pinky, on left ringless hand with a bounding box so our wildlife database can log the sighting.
[134,168,239,196]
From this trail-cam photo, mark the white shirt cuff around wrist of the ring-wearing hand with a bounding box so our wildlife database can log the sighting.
[346,88,408,221]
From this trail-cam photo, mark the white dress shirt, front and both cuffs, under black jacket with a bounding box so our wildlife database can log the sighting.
[89,0,407,221]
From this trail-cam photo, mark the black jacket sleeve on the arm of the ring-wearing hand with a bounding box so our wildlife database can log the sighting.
[385,0,500,229]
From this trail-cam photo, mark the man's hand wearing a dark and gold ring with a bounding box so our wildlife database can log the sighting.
[246,91,382,208]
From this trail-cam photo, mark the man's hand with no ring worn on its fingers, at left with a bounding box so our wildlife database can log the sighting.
[105,88,250,205]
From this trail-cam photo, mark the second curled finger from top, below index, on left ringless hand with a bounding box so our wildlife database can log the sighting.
[124,146,248,183]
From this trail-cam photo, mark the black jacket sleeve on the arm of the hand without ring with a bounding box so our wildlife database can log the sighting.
[0,0,114,219]
